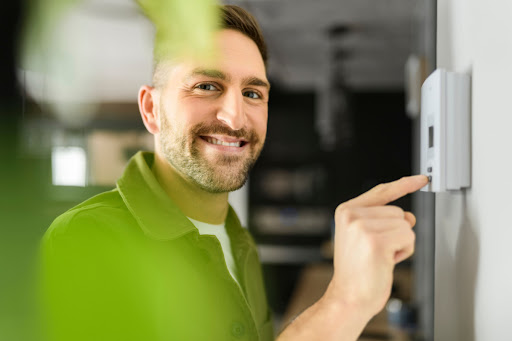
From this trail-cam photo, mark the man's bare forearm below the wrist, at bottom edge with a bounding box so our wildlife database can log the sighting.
[277,290,371,341]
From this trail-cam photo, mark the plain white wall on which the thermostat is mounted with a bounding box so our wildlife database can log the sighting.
[435,0,512,341]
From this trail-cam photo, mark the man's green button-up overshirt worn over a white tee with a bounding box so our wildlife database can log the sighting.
[41,152,273,341]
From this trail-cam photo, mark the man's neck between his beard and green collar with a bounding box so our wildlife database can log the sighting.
[153,153,229,224]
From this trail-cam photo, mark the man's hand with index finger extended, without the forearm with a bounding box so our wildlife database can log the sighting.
[324,175,428,319]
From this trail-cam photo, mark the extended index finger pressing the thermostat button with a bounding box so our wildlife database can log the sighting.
[342,175,428,207]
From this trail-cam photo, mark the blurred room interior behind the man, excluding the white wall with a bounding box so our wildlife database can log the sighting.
[0,0,436,340]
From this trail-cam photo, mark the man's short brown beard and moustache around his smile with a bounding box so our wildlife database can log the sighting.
[159,112,264,193]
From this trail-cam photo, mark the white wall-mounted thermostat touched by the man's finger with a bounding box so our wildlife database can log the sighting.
[421,69,471,192]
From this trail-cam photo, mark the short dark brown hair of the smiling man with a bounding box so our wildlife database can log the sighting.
[153,5,267,87]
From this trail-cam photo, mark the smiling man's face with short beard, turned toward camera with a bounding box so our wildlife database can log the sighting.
[158,30,269,193]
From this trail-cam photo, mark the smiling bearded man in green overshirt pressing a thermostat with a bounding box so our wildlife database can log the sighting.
[43,6,427,340]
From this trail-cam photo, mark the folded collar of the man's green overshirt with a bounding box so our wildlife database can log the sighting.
[117,152,241,240]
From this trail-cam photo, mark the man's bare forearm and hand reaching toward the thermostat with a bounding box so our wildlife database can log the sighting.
[278,175,428,341]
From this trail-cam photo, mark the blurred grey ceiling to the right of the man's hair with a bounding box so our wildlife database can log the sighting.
[226,0,416,89]
